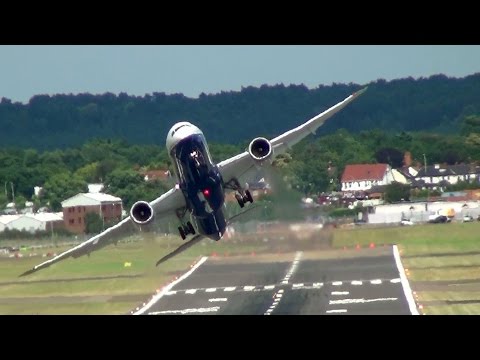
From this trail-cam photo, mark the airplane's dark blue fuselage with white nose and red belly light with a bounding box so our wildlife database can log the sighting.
[166,122,227,240]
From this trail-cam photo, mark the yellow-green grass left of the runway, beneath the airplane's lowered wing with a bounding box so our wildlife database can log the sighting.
[0,237,266,314]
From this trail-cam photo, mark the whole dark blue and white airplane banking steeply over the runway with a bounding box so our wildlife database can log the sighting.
[20,87,367,276]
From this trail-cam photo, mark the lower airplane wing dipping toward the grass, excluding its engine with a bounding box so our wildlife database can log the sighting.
[20,187,185,276]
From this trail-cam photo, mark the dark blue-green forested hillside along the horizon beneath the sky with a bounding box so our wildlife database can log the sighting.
[0,73,480,150]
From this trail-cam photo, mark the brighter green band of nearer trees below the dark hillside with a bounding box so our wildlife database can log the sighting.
[0,115,480,211]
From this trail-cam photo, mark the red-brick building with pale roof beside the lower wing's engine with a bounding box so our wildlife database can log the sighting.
[62,193,123,234]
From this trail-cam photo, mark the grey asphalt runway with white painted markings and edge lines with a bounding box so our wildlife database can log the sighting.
[134,247,418,315]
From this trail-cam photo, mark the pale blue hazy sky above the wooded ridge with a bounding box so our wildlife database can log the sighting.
[0,45,480,103]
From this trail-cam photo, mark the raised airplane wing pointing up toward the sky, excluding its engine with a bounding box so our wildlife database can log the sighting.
[217,87,367,188]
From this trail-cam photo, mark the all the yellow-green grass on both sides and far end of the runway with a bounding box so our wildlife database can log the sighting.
[0,222,480,314]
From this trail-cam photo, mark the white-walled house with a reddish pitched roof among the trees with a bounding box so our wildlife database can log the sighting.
[341,164,400,192]
